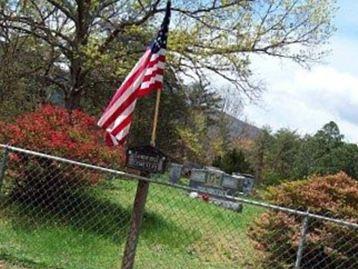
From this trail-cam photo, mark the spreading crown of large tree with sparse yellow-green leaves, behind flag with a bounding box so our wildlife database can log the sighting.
[0,0,335,107]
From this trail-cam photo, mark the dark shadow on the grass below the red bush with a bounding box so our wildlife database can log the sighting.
[0,180,195,247]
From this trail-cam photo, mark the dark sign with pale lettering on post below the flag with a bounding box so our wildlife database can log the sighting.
[127,145,167,173]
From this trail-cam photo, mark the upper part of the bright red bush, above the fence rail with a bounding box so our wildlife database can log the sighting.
[0,105,124,166]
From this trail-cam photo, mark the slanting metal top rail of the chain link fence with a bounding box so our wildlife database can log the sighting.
[0,144,358,229]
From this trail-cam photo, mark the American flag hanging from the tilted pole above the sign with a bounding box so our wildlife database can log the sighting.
[98,1,170,146]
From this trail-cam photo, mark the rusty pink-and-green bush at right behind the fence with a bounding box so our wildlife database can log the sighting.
[249,172,358,268]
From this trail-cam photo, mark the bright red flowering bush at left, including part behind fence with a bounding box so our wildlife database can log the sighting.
[0,105,125,207]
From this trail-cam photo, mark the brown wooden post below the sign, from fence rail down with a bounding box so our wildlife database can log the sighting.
[122,180,149,269]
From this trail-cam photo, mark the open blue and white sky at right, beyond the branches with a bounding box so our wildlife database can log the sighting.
[243,0,358,143]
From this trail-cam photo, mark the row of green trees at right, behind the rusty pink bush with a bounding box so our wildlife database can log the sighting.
[250,121,358,184]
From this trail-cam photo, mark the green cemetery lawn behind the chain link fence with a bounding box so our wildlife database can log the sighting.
[0,177,262,269]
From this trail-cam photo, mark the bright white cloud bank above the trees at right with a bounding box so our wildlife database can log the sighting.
[245,59,358,142]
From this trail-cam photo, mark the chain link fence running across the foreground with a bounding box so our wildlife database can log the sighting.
[0,146,358,269]
